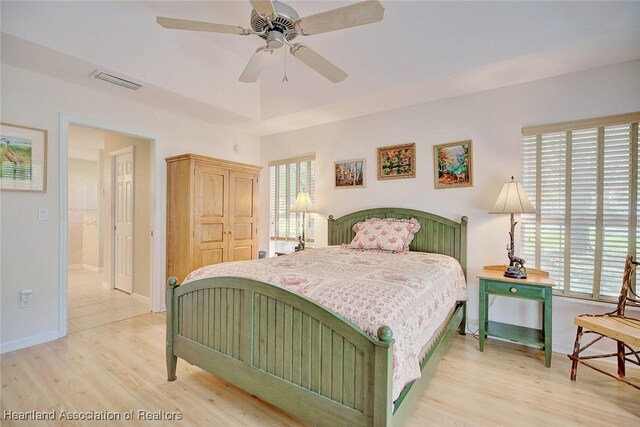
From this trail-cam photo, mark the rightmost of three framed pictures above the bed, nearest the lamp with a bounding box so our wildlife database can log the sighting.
[433,139,473,189]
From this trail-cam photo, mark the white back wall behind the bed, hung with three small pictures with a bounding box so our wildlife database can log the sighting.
[260,61,640,352]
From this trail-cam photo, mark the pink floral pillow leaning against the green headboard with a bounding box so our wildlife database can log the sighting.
[349,218,420,253]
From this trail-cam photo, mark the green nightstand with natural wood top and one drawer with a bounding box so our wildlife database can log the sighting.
[477,265,553,367]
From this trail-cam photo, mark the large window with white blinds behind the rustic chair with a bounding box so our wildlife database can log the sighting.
[520,113,640,301]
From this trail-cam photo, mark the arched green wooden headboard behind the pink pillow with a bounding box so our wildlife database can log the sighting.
[328,208,468,275]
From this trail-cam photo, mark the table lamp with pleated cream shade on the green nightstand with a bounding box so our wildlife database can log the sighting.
[489,177,536,279]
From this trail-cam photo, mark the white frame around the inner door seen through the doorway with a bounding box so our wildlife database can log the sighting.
[108,145,134,295]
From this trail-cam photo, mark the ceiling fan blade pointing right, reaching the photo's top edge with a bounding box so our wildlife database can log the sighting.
[295,0,384,36]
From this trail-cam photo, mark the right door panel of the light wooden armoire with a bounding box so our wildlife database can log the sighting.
[228,171,258,261]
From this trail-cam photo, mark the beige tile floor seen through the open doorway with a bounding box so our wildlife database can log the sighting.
[67,269,150,333]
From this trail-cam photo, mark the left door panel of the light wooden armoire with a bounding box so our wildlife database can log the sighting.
[192,165,229,269]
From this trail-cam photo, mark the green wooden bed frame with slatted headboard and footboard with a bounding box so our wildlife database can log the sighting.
[167,208,467,426]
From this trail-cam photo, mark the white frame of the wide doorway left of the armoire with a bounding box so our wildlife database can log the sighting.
[58,113,159,338]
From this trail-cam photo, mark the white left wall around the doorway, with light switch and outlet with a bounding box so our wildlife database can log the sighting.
[0,64,260,352]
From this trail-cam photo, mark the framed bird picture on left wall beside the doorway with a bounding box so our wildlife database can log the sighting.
[0,122,47,193]
